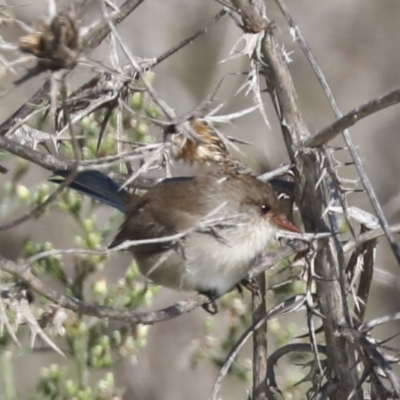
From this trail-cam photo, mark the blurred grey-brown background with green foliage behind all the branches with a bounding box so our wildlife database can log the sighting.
[0,0,400,400]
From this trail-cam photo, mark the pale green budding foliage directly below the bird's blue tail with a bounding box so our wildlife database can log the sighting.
[10,185,153,400]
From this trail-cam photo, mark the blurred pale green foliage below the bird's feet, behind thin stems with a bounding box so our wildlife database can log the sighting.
[183,268,310,390]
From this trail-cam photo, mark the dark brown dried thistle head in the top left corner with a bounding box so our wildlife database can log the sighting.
[19,12,80,70]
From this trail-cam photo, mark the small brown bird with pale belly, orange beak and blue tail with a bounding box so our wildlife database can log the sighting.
[50,170,299,297]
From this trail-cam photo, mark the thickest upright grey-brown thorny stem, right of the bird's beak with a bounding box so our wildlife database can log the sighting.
[261,1,362,399]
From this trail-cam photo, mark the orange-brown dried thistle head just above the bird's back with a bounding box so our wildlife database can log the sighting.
[164,117,230,164]
